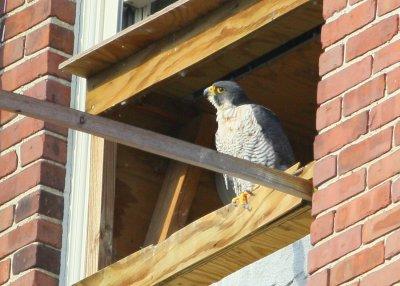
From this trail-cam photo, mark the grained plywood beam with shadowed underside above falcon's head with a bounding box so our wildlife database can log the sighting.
[86,0,321,114]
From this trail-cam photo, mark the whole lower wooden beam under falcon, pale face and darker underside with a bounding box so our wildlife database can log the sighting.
[76,163,312,286]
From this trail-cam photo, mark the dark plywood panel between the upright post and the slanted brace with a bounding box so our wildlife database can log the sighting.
[114,145,168,261]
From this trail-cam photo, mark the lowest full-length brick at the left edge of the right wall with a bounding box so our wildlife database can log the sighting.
[308,226,361,273]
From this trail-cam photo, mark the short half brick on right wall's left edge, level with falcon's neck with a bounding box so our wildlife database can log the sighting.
[316,98,342,130]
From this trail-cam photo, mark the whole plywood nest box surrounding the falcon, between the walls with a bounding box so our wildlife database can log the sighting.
[61,0,322,285]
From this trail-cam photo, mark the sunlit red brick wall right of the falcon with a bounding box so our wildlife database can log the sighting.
[308,0,400,286]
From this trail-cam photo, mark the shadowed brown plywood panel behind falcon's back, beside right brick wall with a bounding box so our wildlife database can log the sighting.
[236,36,322,163]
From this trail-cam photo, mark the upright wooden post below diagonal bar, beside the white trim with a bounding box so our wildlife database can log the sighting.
[86,136,117,275]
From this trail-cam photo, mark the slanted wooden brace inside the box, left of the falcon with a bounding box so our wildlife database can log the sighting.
[144,114,215,245]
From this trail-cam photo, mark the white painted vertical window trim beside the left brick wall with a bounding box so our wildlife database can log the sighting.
[59,0,122,286]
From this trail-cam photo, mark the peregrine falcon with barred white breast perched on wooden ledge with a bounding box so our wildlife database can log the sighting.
[203,81,294,208]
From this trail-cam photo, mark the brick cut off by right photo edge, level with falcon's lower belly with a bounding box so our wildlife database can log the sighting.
[367,147,400,187]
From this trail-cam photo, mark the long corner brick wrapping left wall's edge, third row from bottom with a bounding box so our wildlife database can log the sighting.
[0,219,62,258]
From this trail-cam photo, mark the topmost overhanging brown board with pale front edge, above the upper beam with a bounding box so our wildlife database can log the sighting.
[60,0,227,77]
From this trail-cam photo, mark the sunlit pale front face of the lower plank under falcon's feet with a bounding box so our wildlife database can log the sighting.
[76,162,309,285]
